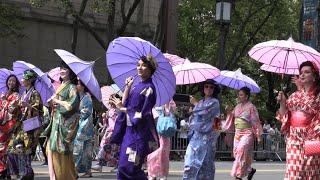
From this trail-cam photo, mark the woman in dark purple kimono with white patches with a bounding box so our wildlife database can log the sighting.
[111,55,157,180]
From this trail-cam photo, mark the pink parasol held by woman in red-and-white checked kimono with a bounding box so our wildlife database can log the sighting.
[248,38,320,73]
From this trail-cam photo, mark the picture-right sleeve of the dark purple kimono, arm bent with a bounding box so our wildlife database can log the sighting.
[130,87,156,125]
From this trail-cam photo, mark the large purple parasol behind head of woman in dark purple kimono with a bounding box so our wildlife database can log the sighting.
[106,37,176,106]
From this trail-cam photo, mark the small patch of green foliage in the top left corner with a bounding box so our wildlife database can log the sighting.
[0,3,23,38]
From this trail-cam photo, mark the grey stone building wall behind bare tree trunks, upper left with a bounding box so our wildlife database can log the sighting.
[0,0,160,84]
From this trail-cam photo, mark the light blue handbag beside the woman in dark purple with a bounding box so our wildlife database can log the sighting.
[157,112,177,138]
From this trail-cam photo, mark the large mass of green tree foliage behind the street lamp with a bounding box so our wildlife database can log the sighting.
[178,0,301,124]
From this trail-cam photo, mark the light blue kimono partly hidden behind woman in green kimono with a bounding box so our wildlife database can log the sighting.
[73,94,94,173]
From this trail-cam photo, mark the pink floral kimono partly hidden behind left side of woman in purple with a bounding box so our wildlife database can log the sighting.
[98,108,120,167]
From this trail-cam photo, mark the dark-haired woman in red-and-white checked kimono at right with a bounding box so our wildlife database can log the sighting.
[277,61,320,180]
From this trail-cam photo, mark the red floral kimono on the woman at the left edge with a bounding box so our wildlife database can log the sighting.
[0,92,20,174]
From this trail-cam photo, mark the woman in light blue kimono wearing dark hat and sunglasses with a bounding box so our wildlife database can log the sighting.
[183,80,220,180]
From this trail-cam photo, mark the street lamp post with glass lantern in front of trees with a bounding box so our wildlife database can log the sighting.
[215,0,231,69]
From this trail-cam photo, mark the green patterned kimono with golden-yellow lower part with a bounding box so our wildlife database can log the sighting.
[44,82,79,180]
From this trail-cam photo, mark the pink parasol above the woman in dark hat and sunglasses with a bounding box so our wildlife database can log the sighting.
[172,59,220,85]
